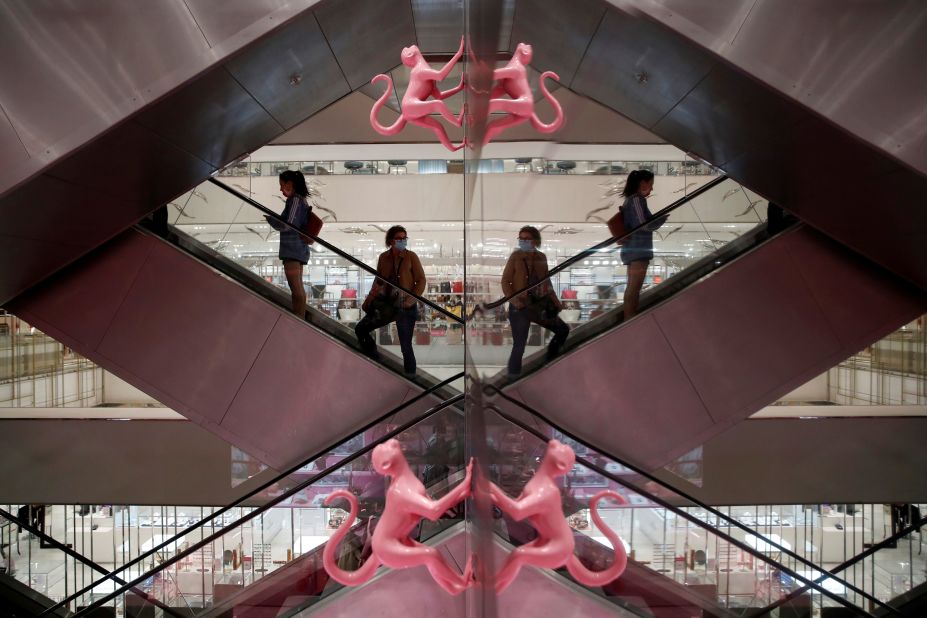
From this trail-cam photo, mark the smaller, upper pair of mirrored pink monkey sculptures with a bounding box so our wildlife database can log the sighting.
[370,37,563,152]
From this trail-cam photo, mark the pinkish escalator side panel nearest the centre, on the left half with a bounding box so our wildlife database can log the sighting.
[221,316,421,469]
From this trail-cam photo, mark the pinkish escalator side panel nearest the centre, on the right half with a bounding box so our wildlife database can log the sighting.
[515,315,712,466]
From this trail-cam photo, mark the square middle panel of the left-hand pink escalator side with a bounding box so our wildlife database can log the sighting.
[99,241,280,425]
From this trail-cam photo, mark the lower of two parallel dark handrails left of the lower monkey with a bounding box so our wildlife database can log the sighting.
[67,394,464,618]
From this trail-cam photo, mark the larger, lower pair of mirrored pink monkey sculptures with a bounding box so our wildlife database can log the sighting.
[322,440,628,595]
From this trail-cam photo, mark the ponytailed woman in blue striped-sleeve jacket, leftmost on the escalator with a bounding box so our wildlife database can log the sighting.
[264,170,312,318]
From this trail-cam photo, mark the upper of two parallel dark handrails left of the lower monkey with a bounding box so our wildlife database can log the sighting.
[40,371,464,616]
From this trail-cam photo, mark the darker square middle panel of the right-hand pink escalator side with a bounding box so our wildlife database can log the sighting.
[654,229,840,421]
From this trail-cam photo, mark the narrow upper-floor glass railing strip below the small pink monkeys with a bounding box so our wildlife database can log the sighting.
[218,157,719,179]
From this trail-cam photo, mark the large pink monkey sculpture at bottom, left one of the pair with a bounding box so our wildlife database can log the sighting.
[322,440,473,595]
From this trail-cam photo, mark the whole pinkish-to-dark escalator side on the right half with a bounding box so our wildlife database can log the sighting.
[511,228,927,469]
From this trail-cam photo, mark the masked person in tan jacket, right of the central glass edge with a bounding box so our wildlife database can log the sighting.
[502,225,570,378]
